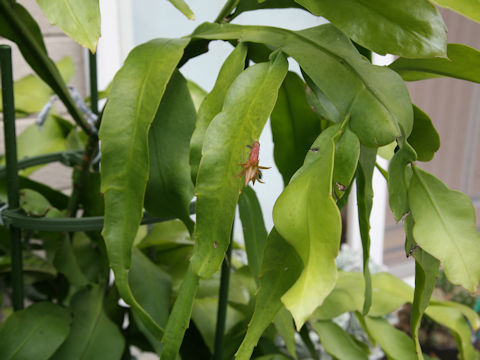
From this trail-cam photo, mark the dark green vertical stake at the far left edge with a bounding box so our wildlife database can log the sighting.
[0,45,23,310]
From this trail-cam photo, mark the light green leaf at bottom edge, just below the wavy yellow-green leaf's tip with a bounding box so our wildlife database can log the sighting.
[312,321,368,360]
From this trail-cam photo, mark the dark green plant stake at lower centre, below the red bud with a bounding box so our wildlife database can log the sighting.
[213,224,234,360]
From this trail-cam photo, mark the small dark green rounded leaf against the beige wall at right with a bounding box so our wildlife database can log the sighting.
[408,105,440,161]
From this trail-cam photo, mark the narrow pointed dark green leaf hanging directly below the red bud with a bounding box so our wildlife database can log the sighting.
[238,186,268,280]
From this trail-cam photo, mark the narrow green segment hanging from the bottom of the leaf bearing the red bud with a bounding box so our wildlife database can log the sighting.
[161,266,200,360]
